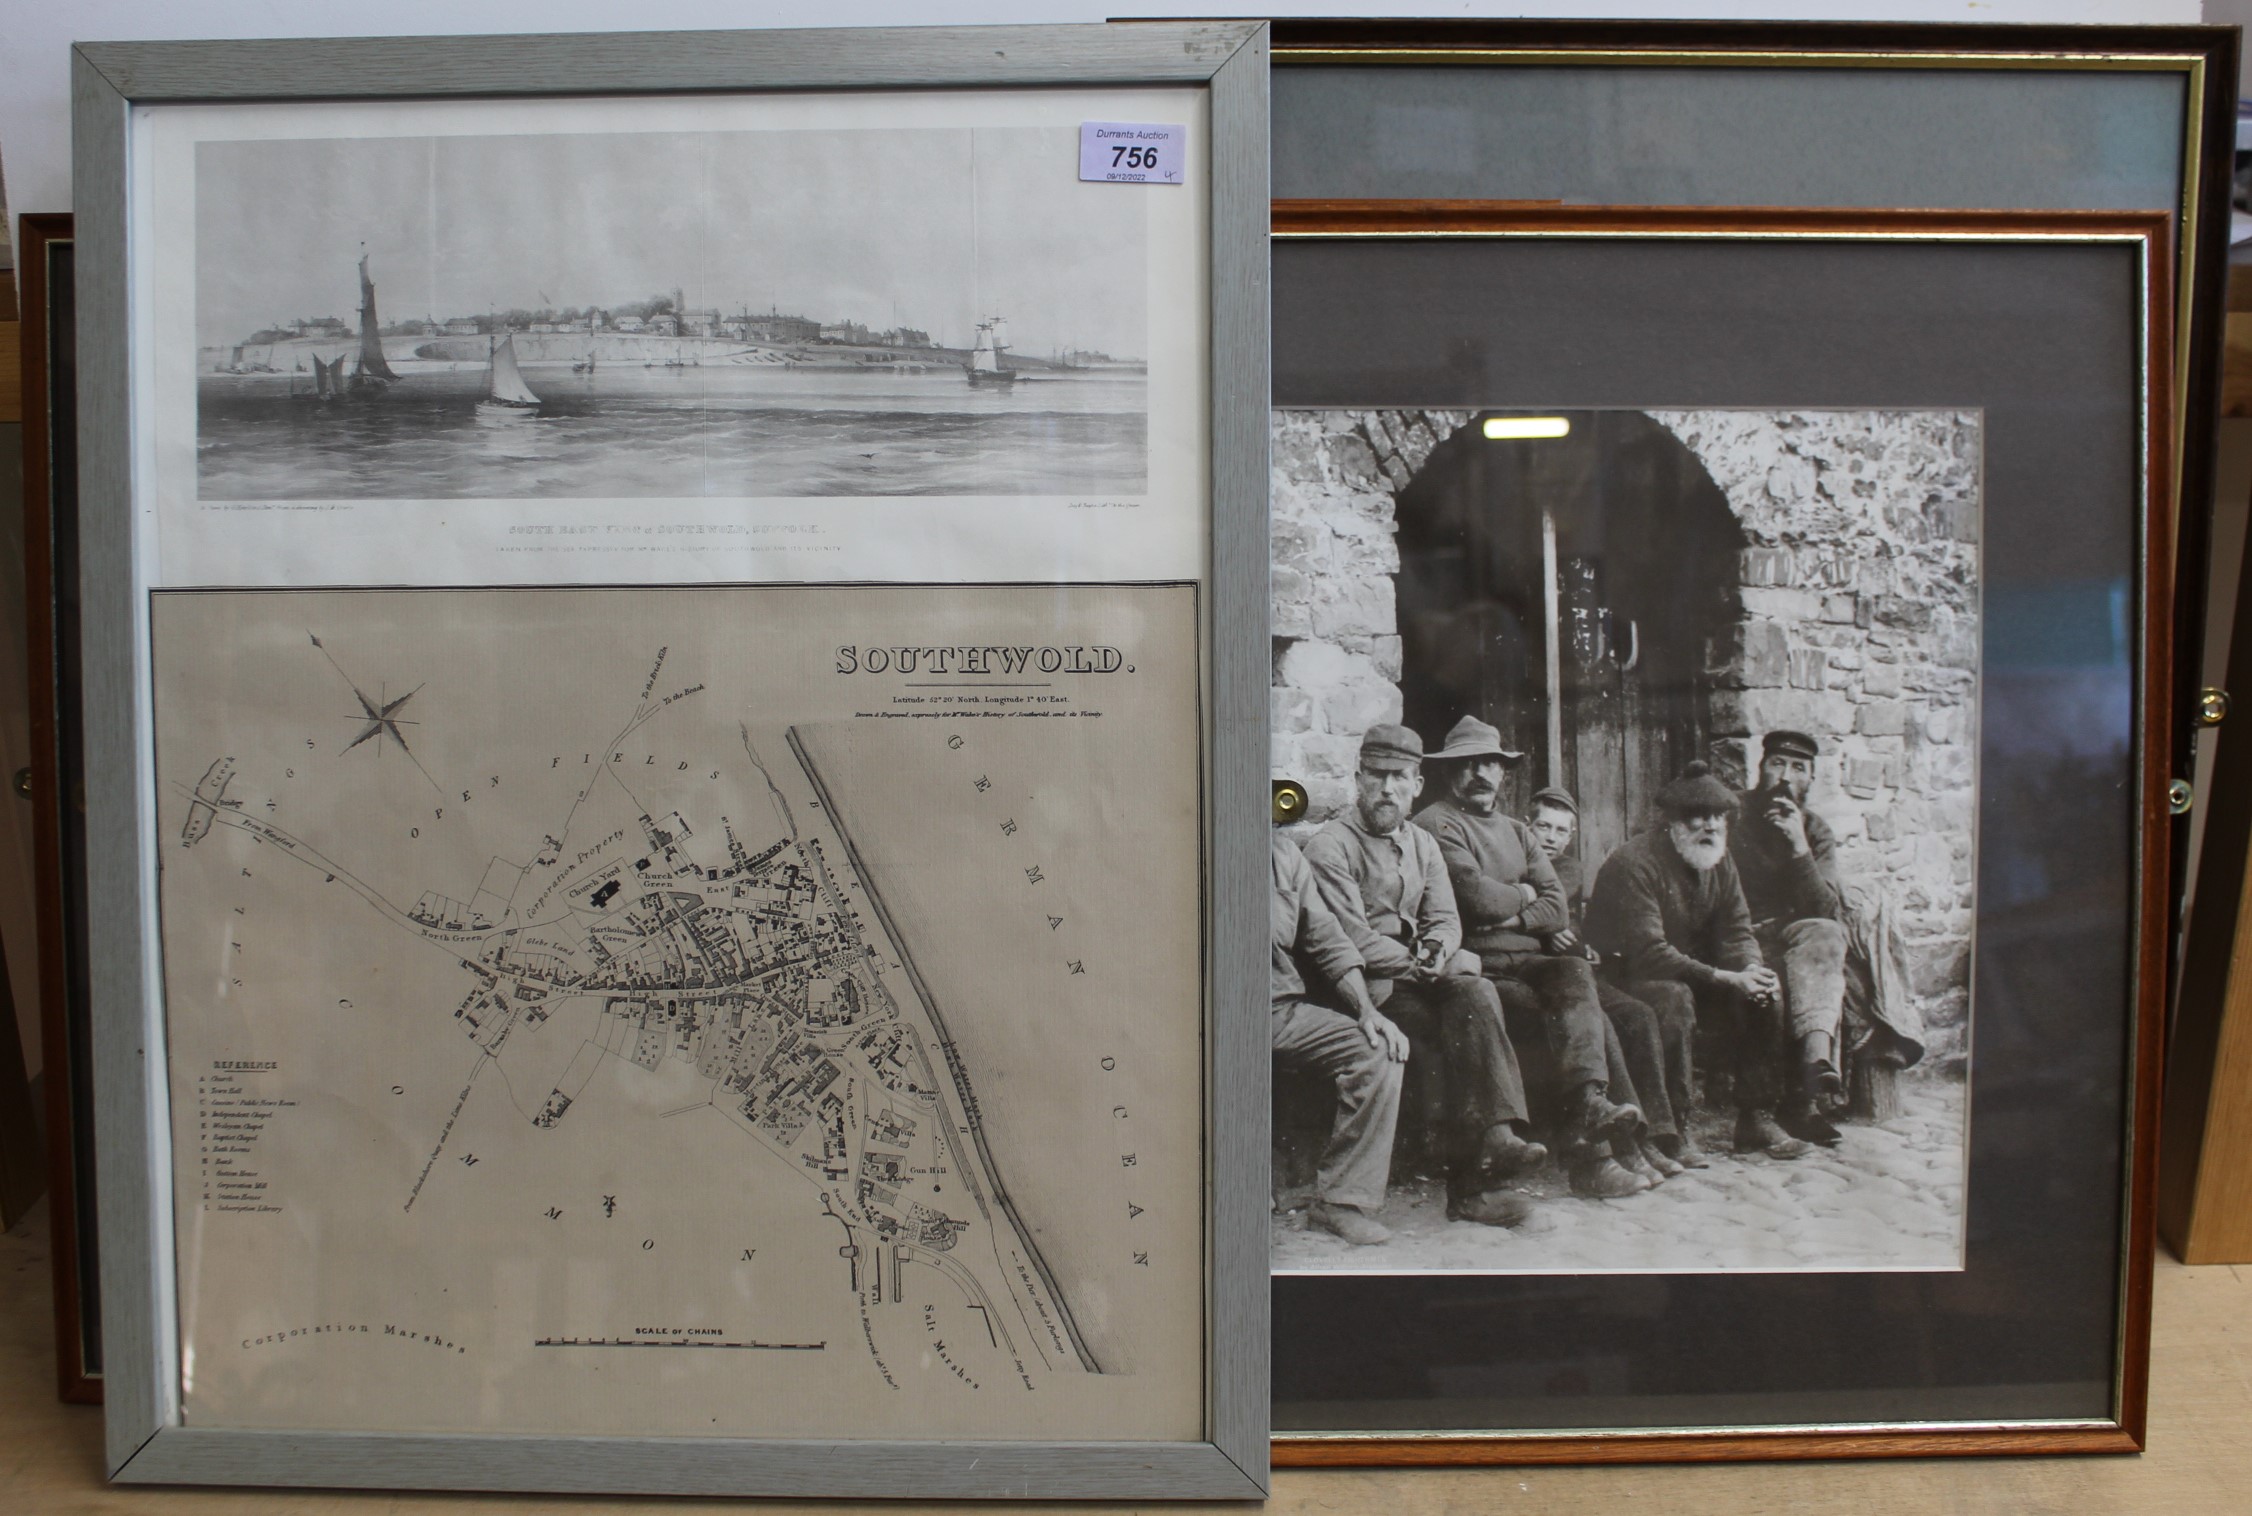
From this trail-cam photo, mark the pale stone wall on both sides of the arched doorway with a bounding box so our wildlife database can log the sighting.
[1270,400,1980,1054]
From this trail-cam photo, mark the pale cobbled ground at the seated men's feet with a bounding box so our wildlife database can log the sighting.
[1272,1074,1964,1273]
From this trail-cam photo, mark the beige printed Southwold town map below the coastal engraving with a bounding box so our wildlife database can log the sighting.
[153,586,1203,1437]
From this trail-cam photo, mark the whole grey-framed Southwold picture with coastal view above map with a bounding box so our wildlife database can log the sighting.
[77,25,1268,1498]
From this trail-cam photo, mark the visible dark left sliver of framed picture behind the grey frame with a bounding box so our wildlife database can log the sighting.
[18,214,101,1406]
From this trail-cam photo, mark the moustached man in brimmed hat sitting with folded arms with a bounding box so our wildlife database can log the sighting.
[1414,716,1648,1201]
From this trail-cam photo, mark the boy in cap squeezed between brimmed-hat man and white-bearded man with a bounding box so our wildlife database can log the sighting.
[1525,784,1709,1183]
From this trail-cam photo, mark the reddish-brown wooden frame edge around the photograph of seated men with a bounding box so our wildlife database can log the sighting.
[1272,200,2170,1469]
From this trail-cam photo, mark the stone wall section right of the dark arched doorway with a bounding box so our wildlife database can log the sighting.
[1651,410,1980,1052]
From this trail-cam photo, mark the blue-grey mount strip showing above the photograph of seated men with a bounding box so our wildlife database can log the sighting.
[1275,63,2189,209]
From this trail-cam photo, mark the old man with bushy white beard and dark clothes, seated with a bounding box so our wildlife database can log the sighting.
[1588,761,1811,1158]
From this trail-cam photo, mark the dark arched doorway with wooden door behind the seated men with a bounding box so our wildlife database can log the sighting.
[1398,410,1743,870]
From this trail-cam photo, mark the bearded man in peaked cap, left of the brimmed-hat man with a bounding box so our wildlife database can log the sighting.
[1304,725,1547,1225]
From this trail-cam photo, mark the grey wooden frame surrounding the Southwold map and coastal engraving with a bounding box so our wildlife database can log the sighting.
[72,23,1268,1500]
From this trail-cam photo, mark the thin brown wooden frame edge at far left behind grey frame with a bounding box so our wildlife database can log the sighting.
[16,214,101,1406]
